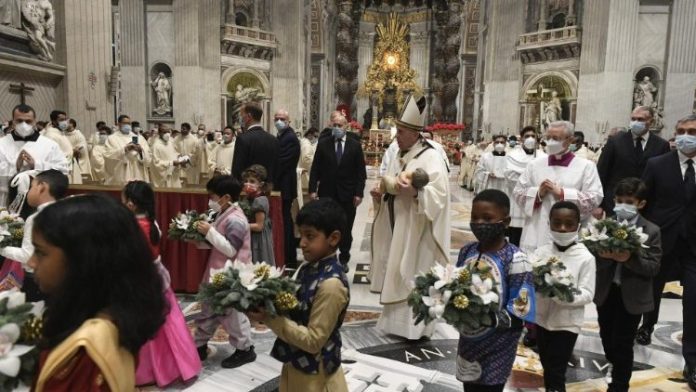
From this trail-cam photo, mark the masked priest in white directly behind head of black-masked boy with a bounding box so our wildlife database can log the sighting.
[474,135,508,193]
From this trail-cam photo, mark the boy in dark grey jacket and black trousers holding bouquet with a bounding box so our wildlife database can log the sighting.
[594,177,662,392]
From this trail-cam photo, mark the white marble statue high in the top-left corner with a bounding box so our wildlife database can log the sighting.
[21,0,56,61]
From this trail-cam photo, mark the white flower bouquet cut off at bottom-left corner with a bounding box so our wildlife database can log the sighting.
[0,289,43,391]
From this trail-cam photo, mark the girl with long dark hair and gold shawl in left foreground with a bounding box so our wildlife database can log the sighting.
[29,195,167,392]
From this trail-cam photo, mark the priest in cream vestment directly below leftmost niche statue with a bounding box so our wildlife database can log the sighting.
[150,125,186,188]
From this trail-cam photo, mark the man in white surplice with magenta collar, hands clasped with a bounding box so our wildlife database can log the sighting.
[513,121,604,253]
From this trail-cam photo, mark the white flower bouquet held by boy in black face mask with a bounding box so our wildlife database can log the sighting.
[408,262,500,332]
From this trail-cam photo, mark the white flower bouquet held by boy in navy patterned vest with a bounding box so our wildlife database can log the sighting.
[198,260,299,315]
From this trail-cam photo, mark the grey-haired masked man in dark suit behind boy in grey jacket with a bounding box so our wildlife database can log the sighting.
[597,106,669,215]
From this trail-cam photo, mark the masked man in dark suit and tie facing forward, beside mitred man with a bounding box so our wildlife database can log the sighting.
[309,110,367,271]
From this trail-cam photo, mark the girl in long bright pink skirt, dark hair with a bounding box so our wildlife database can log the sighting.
[121,181,201,388]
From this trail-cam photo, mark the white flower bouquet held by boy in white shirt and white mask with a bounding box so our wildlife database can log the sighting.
[532,256,578,302]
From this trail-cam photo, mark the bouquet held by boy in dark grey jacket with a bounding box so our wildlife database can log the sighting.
[580,218,648,254]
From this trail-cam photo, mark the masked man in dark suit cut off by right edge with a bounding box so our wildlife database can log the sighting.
[636,115,696,389]
